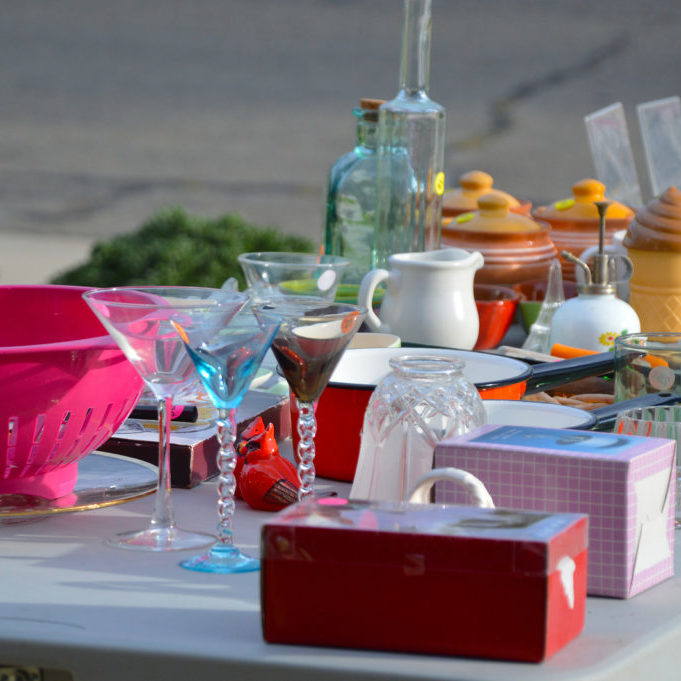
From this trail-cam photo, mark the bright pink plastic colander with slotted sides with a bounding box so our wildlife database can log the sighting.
[0,285,143,499]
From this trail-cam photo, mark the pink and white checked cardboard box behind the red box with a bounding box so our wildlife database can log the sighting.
[435,426,676,598]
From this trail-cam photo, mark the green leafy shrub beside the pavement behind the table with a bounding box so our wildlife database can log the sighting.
[52,208,315,290]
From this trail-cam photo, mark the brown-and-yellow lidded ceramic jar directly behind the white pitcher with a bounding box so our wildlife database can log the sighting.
[442,193,558,285]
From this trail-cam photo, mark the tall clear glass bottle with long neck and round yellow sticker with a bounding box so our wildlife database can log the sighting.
[372,0,446,267]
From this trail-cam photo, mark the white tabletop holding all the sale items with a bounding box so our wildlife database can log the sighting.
[0,452,681,681]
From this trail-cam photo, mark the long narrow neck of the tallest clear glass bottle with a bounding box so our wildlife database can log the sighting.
[400,0,432,96]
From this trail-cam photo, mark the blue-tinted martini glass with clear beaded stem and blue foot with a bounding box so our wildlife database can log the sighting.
[177,309,281,573]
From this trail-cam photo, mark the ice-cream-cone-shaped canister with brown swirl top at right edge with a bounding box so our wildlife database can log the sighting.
[623,187,681,333]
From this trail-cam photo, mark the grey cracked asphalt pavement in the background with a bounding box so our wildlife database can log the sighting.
[0,0,681,283]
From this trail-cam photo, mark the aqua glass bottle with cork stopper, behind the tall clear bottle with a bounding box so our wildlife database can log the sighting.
[324,99,384,284]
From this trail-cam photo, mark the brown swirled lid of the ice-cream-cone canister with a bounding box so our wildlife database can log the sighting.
[624,187,681,252]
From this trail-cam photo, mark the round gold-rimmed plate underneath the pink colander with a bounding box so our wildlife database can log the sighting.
[0,452,158,524]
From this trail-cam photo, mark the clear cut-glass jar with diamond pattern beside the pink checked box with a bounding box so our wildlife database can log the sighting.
[350,355,486,501]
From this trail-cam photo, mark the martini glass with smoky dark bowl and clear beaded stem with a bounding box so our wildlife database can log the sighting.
[255,296,366,501]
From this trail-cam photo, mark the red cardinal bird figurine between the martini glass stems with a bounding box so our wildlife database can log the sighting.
[235,417,300,511]
